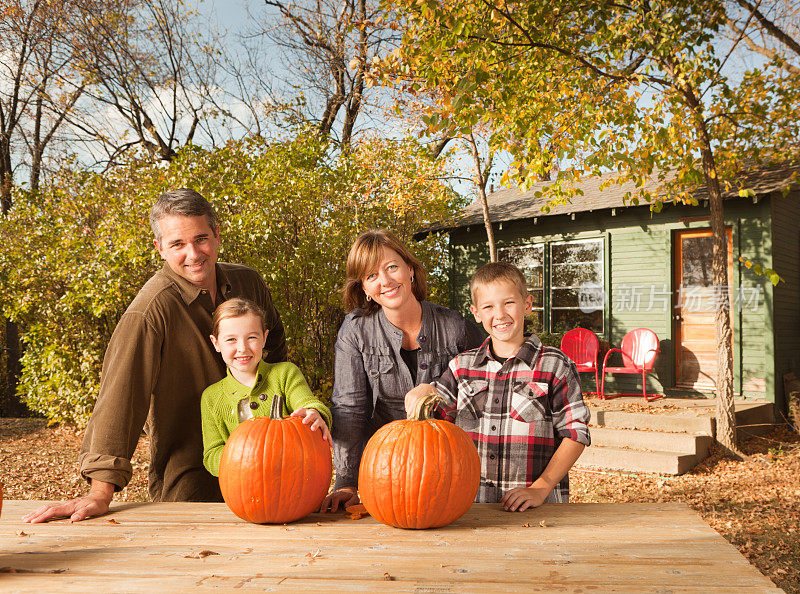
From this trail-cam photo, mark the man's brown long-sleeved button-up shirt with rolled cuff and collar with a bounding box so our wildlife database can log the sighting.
[79,262,286,501]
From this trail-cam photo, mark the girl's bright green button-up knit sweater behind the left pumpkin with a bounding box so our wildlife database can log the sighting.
[200,361,331,476]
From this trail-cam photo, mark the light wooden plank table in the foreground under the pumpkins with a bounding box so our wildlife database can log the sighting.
[0,501,780,594]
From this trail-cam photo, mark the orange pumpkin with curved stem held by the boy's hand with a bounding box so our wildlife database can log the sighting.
[358,399,481,528]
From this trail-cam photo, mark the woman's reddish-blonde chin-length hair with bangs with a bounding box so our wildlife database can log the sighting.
[342,229,428,313]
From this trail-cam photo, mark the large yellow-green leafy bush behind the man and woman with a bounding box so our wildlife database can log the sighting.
[0,134,460,425]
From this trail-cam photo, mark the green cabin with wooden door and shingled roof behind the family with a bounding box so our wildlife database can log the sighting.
[438,168,800,410]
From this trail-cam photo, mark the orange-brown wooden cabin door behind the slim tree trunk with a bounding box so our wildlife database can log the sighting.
[673,228,733,391]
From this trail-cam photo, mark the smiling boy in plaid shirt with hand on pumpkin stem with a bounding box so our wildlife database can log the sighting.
[405,262,590,511]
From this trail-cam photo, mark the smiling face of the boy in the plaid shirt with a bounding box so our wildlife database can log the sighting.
[470,279,533,346]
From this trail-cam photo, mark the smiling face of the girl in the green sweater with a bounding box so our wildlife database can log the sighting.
[211,313,267,375]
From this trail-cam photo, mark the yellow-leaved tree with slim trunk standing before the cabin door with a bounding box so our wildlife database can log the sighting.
[387,0,798,453]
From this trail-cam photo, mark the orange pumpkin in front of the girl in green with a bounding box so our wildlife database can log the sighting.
[219,417,333,524]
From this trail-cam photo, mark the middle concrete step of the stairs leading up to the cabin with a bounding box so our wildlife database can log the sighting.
[589,427,714,460]
